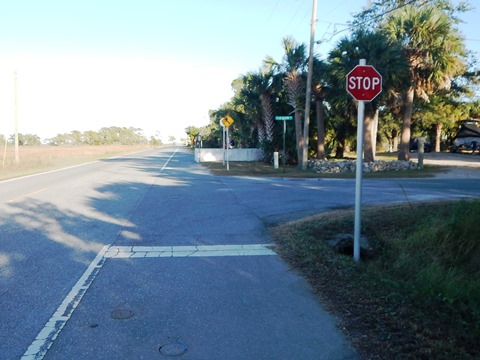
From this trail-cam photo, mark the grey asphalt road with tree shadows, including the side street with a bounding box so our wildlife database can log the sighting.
[0,147,480,359]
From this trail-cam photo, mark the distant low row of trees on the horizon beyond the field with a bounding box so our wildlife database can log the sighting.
[0,126,162,146]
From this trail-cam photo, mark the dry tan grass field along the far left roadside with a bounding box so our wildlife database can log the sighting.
[0,145,152,180]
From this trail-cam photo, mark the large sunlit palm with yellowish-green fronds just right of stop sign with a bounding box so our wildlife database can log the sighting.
[383,5,465,160]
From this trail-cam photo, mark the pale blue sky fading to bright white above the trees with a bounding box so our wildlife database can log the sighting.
[0,0,480,138]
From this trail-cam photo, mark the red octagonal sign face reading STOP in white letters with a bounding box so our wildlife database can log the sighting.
[347,65,382,101]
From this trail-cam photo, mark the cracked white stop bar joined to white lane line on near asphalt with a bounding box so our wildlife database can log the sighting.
[21,243,276,360]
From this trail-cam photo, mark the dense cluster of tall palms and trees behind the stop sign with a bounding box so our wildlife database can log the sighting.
[186,0,480,167]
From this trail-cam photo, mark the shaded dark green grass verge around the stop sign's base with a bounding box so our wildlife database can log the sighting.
[271,200,480,359]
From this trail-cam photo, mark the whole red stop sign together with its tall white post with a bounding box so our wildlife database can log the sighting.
[347,59,382,262]
